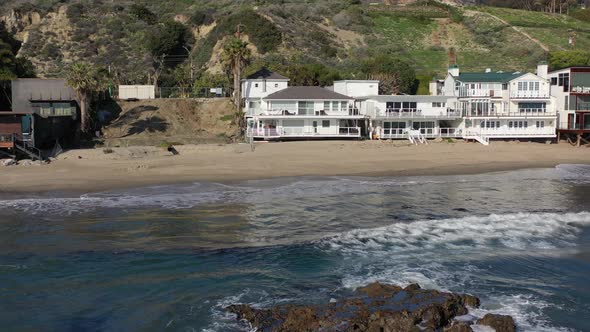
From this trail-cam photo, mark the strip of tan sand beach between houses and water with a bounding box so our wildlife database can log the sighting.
[0,141,590,193]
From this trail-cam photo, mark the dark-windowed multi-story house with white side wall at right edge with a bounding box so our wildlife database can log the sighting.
[548,66,590,134]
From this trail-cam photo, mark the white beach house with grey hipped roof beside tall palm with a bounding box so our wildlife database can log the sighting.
[242,68,379,140]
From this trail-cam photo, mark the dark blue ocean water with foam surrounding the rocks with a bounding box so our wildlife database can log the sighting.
[0,165,590,331]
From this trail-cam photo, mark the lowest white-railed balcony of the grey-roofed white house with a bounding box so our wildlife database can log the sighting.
[247,127,361,138]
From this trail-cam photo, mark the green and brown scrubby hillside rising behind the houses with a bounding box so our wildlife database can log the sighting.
[0,0,590,86]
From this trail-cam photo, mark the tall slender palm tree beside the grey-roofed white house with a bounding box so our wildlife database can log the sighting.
[222,37,252,129]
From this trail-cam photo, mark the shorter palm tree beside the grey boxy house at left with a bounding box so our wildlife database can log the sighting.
[66,62,108,132]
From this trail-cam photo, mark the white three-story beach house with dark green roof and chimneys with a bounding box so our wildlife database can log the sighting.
[431,64,557,143]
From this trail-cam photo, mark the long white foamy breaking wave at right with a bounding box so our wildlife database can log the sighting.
[318,212,590,255]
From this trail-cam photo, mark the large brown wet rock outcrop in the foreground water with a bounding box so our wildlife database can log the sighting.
[226,283,494,332]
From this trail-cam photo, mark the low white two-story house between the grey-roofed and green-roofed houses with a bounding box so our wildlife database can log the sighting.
[357,95,462,139]
